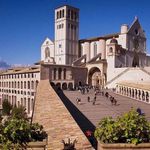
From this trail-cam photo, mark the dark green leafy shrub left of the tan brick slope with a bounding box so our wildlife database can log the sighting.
[0,107,47,150]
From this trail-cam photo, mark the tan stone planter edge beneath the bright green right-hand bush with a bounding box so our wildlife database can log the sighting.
[98,142,150,150]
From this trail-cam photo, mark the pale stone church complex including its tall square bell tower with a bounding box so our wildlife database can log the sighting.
[41,5,150,88]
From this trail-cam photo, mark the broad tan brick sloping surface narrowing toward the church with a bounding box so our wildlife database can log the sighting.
[33,80,92,150]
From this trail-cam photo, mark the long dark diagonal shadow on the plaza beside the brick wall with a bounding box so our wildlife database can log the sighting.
[55,89,97,150]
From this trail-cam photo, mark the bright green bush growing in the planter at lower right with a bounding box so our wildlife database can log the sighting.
[94,109,150,144]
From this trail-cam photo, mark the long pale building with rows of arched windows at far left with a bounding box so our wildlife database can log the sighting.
[0,66,40,117]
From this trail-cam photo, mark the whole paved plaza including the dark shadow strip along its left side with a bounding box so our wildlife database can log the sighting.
[58,89,150,149]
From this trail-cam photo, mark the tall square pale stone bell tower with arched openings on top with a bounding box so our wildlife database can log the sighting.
[55,5,79,65]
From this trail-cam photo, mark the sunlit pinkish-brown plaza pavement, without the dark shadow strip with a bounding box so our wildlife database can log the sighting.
[63,90,150,126]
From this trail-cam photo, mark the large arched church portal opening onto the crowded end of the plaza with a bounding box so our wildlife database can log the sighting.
[88,67,102,87]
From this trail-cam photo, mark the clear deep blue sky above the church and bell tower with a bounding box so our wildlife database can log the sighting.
[0,0,150,64]
